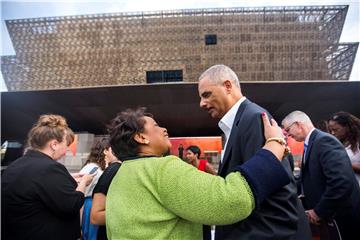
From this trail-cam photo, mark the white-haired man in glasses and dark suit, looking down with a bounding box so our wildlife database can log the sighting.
[282,111,360,239]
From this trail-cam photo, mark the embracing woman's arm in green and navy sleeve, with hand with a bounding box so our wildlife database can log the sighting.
[157,112,290,225]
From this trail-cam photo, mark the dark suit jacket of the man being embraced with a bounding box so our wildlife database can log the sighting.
[215,100,310,240]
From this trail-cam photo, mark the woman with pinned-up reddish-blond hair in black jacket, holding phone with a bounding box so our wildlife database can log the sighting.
[1,115,93,240]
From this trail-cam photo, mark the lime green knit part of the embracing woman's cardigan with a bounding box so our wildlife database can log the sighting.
[106,156,255,239]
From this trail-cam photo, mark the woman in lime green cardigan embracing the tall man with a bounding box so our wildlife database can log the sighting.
[106,108,290,239]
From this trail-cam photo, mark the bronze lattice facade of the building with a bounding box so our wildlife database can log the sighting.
[1,5,358,91]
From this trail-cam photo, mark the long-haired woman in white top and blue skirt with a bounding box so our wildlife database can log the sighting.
[80,138,107,240]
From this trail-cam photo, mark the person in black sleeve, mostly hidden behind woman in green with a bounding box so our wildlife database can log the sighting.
[90,139,121,240]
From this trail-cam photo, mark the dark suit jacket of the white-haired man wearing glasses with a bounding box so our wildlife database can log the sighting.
[301,129,360,239]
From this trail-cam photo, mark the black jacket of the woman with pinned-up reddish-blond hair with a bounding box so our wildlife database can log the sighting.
[1,150,84,240]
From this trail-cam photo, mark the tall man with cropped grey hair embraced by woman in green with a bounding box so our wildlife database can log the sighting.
[198,65,310,240]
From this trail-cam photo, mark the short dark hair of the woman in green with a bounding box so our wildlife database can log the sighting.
[107,107,153,159]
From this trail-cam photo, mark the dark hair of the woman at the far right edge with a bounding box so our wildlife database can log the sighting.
[330,112,360,152]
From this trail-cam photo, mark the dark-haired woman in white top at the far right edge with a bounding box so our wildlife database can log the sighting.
[329,112,360,185]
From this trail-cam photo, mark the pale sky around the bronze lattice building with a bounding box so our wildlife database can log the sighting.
[0,0,360,91]
